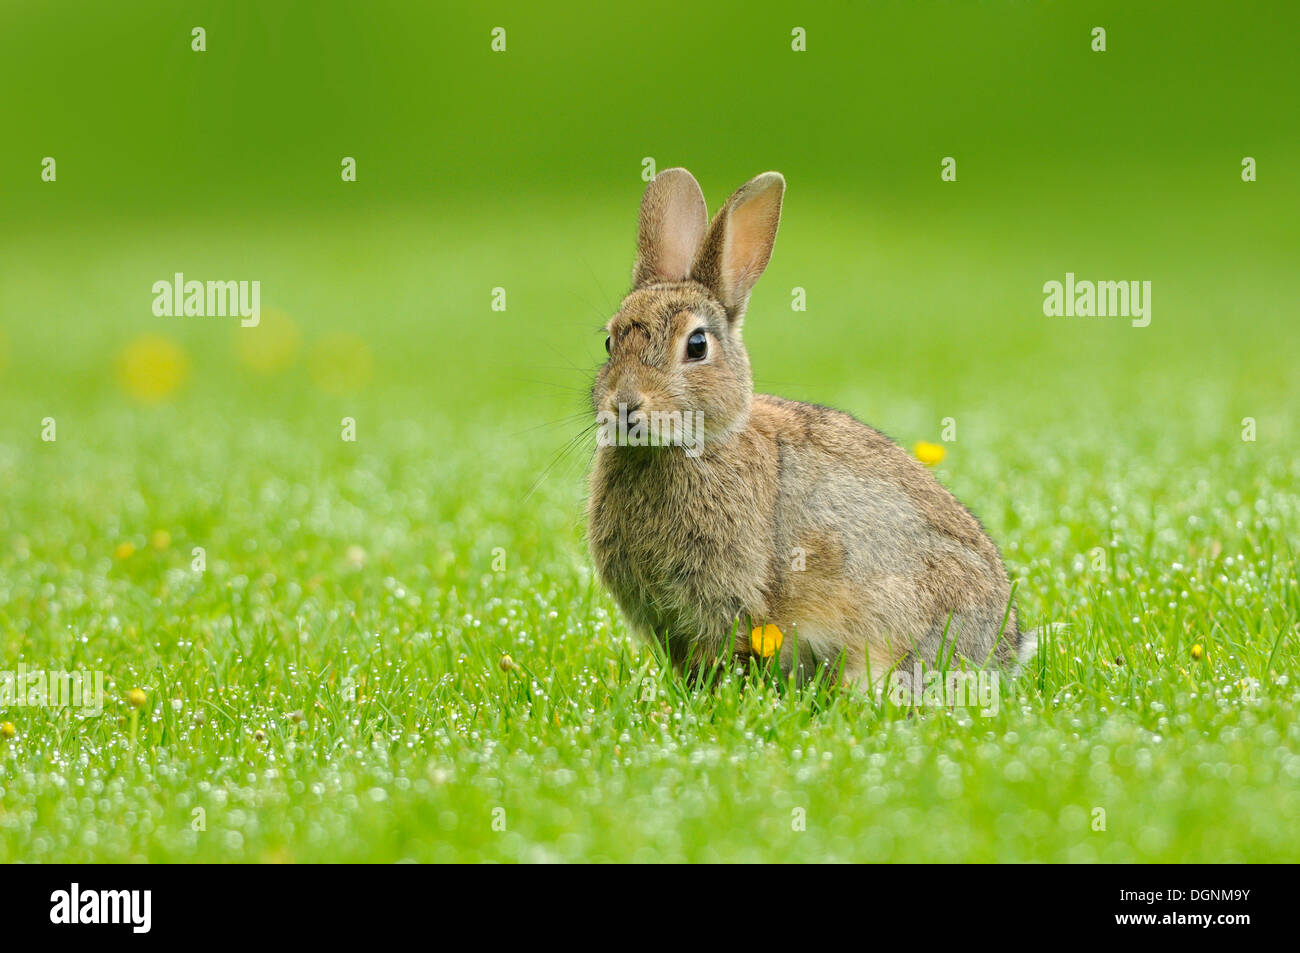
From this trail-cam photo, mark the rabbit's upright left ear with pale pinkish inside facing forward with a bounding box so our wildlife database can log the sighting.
[632,169,709,287]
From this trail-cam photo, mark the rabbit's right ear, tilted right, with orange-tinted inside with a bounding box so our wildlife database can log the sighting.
[690,172,785,322]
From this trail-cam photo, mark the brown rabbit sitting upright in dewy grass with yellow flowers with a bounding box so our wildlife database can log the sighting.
[588,169,1034,688]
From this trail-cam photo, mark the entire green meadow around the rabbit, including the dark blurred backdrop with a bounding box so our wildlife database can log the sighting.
[0,4,1300,862]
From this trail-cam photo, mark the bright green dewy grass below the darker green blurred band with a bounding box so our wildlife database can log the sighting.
[0,182,1300,861]
